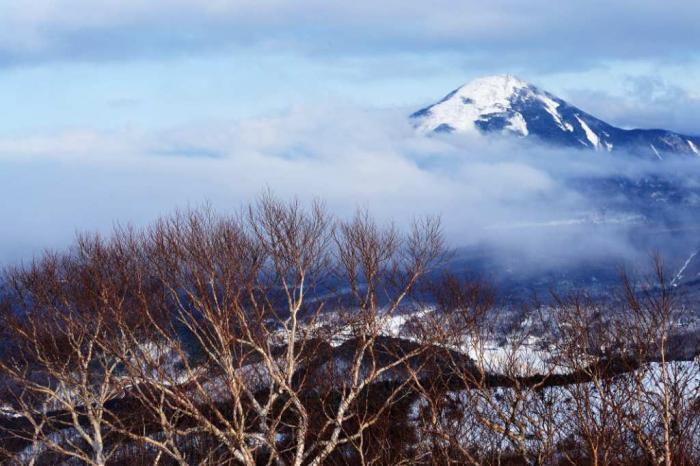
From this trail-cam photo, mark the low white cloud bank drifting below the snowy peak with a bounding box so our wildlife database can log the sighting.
[0,104,700,274]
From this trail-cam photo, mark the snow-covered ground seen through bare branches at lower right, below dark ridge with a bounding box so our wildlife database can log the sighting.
[411,361,700,454]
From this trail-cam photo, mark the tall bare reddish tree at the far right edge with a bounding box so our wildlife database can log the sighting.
[619,256,700,465]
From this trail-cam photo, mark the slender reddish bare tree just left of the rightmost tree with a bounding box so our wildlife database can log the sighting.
[547,295,631,465]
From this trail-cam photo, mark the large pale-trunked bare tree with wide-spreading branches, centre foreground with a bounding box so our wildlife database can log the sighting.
[28,197,445,465]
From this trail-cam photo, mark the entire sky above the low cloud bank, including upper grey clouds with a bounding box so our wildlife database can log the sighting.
[0,0,700,134]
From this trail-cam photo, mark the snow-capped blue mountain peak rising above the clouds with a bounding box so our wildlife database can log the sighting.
[411,75,700,159]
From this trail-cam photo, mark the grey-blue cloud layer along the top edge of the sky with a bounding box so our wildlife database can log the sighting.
[0,0,700,70]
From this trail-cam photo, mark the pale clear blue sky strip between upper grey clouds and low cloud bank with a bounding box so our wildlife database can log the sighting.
[0,55,698,133]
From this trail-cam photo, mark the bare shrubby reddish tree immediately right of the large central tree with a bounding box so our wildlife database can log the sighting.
[408,277,558,464]
